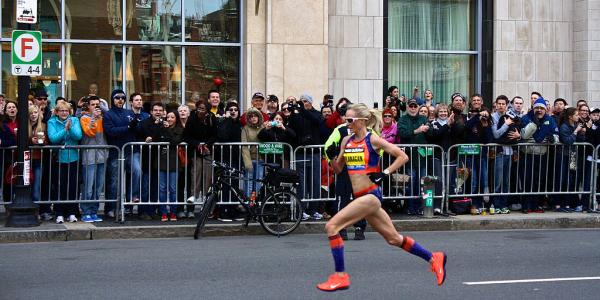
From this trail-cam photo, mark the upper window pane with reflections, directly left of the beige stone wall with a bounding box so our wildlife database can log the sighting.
[184,0,240,42]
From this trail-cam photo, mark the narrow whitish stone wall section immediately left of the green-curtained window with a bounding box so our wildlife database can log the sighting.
[328,0,385,105]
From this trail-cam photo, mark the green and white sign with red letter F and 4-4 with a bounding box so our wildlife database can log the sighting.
[11,30,42,76]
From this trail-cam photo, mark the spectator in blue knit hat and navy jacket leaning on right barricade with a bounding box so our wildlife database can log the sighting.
[519,98,558,213]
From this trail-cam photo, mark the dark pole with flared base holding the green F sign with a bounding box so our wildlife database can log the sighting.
[6,23,40,227]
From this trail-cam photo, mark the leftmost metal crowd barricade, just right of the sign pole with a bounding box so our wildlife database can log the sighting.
[30,145,120,217]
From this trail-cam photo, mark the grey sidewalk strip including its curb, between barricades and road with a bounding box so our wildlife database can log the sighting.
[0,212,600,243]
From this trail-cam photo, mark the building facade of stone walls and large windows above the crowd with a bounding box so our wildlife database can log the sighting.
[0,0,600,105]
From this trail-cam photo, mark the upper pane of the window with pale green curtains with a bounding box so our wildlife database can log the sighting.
[388,0,476,50]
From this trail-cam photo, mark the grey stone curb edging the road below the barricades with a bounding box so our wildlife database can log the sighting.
[0,215,600,243]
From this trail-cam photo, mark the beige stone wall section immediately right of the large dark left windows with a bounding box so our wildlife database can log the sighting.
[242,0,328,108]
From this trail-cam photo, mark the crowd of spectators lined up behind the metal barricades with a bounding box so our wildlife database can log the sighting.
[0,86,600,224]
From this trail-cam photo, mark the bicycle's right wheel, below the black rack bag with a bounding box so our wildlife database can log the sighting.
[258,190,303,236]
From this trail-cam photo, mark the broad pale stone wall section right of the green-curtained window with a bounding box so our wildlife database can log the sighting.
[494,0,574,105]
